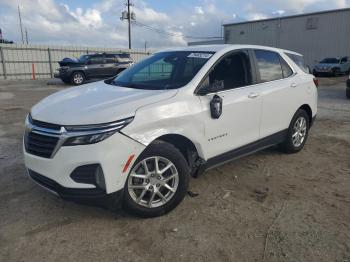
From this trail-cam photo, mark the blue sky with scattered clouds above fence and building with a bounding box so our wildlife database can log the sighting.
[0,0,350,48]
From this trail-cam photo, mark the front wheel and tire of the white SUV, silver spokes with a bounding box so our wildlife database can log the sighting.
[123,141,189,217]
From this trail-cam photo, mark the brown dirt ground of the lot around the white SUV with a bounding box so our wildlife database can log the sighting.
[0,77,350,262]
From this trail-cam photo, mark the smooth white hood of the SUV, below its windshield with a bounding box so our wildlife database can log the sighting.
[31,81,177,125]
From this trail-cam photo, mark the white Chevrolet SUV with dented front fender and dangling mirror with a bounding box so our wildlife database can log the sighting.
[24,45,317,217]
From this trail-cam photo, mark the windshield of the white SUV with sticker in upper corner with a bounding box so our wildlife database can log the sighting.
[112,51,214,90]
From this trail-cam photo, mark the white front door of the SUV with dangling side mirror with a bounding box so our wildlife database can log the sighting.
[199,50,262,159]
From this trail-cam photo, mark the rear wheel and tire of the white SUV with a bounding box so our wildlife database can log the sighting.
[281,109,310,154]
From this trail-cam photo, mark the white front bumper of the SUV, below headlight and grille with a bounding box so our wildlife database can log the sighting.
[24,132,145,197]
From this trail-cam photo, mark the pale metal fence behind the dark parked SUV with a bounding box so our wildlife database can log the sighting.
[0,44,154,79]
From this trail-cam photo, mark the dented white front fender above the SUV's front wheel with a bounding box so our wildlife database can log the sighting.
[122,96,205,158]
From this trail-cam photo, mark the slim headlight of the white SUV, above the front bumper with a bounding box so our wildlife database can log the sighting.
[63,117,133,146]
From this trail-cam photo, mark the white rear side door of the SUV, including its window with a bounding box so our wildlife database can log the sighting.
[254,50,299,138]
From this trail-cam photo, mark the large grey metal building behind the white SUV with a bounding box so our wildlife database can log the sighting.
[224,8,350,67]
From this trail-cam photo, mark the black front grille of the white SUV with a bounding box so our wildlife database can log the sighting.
[24,131,59,158]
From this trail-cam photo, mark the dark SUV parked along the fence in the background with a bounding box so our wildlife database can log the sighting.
[55,53,133,85]
